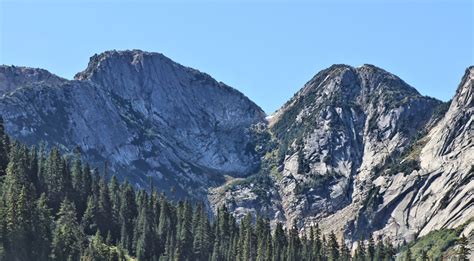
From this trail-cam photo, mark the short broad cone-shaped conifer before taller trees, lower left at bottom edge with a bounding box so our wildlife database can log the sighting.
[51,199,85,260]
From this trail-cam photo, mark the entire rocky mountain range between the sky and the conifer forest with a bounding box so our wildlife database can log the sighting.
[0,51,474,242]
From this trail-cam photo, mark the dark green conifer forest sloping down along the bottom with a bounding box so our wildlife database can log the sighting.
[0,116,468,261]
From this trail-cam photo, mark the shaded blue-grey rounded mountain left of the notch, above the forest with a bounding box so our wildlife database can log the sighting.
[0,50,265,196]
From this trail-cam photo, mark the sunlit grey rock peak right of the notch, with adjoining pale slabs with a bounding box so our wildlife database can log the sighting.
[210,65,473,242]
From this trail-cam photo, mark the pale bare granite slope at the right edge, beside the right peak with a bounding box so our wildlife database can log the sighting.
[370,67,474,239]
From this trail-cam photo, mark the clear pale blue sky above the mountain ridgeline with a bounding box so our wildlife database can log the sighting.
[0,0,474,113]
